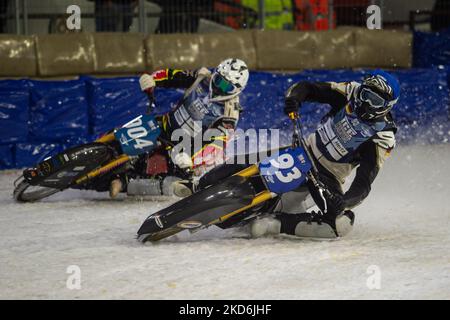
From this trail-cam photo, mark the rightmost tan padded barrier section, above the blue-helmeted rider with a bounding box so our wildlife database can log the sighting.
[254,27,413,70]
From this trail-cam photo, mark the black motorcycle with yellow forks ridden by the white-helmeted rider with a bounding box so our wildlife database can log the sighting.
[13,97,179,202]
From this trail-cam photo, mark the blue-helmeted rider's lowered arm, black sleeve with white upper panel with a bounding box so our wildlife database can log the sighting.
[344,131,395,209]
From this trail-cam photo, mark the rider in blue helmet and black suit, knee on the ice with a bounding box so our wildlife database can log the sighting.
[250,70,400,238]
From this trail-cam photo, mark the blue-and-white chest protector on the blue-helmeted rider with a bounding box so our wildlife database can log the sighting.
[315,105,387,163]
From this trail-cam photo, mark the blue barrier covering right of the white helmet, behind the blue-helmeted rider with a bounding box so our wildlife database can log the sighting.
[239,68,450,143]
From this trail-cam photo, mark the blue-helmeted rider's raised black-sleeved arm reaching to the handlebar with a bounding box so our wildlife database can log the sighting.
[285,81,351,108]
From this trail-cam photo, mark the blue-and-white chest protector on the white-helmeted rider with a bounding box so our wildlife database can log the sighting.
[169,81,224,137]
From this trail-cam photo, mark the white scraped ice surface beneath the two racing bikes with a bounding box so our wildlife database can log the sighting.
[0,144,450,299]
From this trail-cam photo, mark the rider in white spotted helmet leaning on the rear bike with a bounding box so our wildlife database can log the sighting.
[109,59,249,198]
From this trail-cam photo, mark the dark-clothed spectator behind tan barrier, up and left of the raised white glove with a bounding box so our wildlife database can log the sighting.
[88,0,137,32]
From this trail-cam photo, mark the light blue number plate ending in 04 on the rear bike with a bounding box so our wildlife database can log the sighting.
[114,115,161,156]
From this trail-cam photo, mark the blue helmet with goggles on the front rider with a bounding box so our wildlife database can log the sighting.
[353,70,400,120]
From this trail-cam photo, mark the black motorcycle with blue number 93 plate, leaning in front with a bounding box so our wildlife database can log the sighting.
[137,113,330,243]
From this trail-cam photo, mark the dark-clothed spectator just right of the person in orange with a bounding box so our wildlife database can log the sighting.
[333,0,371,26]
